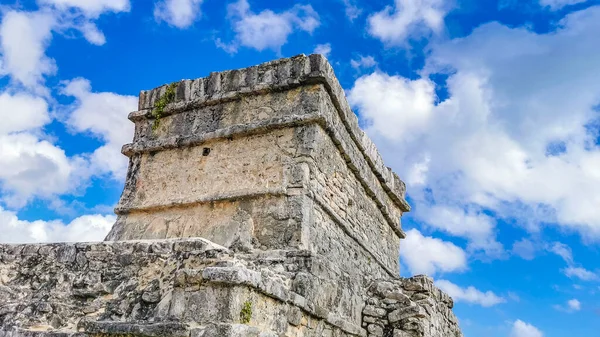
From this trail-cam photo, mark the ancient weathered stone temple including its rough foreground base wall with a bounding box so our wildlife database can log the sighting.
[0,55,462,337]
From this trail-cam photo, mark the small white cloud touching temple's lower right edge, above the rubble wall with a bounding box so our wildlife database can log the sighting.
[400,229,467,276]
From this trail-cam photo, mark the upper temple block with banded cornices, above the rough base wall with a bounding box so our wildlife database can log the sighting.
[107,55,409,275]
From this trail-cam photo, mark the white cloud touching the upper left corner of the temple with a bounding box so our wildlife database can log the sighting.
[63,78,137,179]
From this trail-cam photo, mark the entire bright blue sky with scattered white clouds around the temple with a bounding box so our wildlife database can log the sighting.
[0,0,600,337]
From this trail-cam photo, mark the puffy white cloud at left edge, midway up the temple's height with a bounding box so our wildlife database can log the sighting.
[0,92,83,207]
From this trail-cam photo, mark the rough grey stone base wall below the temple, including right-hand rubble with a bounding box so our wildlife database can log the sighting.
[0,239,462,337]
